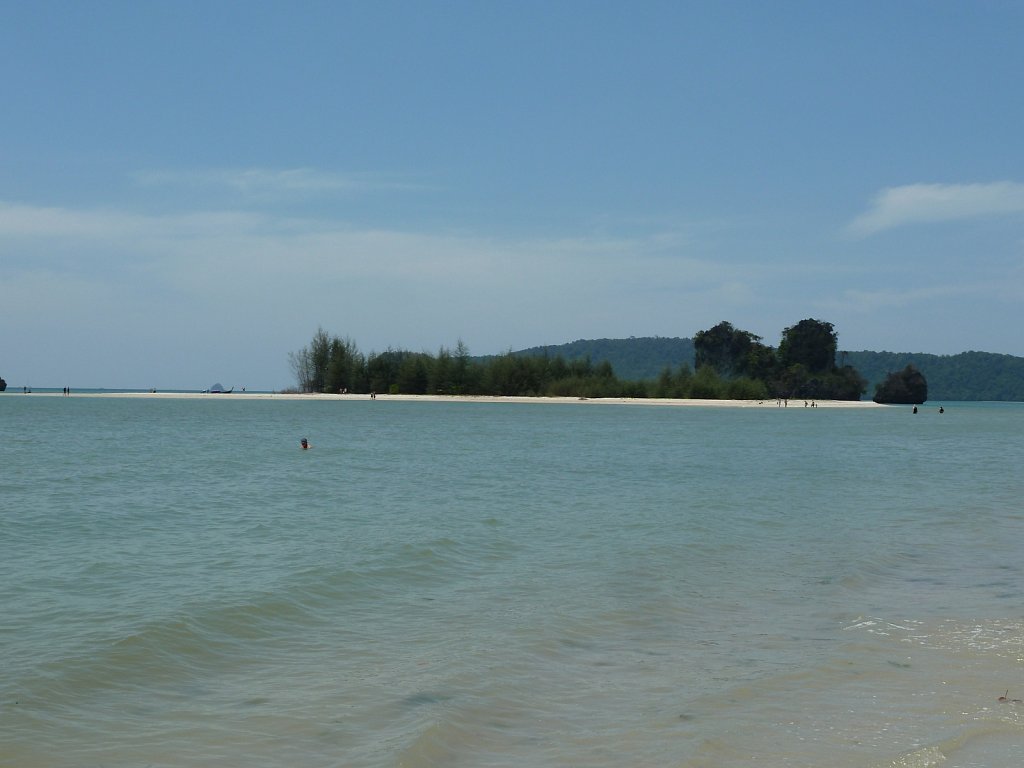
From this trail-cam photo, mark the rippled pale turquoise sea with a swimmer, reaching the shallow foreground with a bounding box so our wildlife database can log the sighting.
[0,391,1024,768]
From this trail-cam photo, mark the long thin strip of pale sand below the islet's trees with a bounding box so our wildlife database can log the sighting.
[11,390,885,409]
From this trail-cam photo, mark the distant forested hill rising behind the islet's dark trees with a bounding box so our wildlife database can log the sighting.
[503,336,1024,401]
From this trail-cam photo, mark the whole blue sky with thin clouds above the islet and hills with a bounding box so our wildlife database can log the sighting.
[0,0,1024,390]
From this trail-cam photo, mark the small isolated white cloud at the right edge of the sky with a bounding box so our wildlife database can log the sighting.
[847,181,1024,237]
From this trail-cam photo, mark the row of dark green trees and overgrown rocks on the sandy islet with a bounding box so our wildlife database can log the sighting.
[289,319,866,400]
